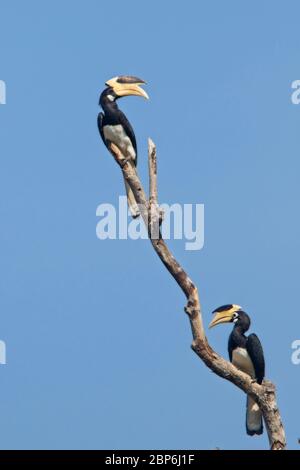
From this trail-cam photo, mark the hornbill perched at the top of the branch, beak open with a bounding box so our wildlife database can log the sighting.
[98,76,149,217]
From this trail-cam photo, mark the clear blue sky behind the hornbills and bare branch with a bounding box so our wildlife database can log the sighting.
[0,0,300,449]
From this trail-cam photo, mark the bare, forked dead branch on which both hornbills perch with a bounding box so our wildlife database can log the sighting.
[111,139,286,450]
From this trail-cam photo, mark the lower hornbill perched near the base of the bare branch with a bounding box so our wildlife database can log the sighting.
[209,304,265,436]
